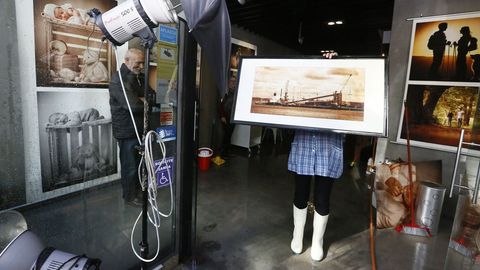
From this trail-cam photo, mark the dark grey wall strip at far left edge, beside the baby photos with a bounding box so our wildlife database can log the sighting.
[0,1,25,207]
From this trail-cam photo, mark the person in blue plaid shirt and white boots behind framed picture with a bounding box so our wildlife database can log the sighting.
[288,53,345,261]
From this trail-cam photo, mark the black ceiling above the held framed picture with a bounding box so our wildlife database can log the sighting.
[226,0,394,55]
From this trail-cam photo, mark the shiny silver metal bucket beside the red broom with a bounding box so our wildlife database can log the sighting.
[415,182,446,235]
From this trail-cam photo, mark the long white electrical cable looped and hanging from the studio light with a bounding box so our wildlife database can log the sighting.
[112,45,174,262]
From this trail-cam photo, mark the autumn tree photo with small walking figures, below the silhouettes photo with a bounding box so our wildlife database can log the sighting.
[400,85,480,146]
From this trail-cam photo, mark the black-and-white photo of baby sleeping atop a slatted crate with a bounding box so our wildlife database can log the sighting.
[38,92,117,192]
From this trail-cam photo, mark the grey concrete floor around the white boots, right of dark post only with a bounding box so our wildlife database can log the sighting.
[179,137,457,270]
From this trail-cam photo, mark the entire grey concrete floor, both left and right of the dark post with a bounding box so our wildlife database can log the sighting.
[15,133,477,270]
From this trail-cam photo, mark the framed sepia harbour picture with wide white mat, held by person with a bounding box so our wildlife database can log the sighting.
[232,57,387,136]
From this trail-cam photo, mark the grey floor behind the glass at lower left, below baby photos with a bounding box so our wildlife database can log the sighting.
[20,182,173,270]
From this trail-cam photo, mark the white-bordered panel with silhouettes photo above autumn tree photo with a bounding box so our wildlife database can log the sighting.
[397,12,480,151]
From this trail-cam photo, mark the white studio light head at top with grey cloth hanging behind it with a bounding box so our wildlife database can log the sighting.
[88,0,232,96]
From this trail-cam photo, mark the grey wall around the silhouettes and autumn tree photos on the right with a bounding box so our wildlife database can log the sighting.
[386,0,480,215]
